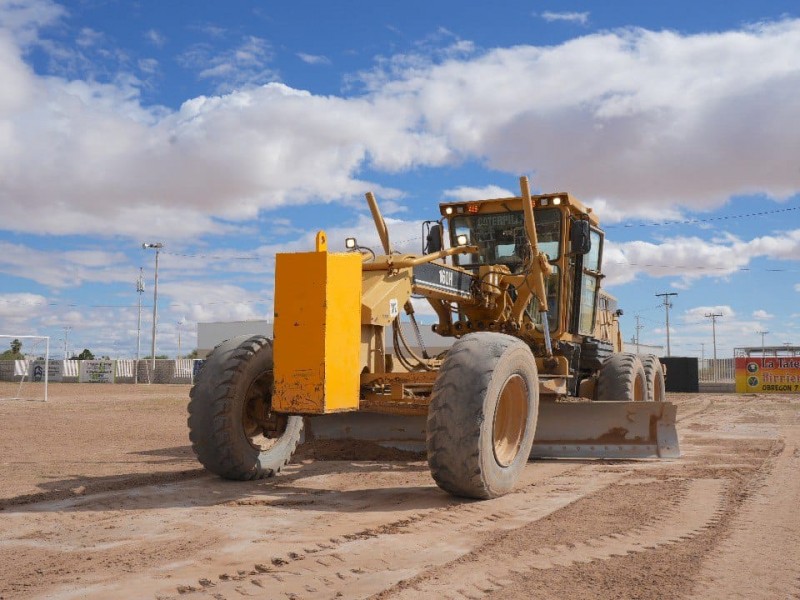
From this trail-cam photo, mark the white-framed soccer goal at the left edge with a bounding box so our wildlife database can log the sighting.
[0,334,50,402]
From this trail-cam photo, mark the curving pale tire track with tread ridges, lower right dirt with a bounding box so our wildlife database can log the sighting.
[379,479,725,600]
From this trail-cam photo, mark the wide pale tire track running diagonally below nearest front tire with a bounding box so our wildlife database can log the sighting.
[167,466,627,599]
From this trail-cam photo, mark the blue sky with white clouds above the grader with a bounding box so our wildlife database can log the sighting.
[0,0,800,358]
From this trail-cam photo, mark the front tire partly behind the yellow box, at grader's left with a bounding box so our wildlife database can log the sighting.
[188,335,303,480]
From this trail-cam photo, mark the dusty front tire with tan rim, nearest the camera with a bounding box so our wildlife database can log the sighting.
[426,332,539,499]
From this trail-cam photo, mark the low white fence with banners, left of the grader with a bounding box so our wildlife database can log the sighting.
[0,358,205,383]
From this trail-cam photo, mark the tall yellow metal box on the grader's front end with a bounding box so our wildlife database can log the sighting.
[272,231,362,414]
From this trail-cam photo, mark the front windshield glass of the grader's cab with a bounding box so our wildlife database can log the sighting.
[450,208,561,272]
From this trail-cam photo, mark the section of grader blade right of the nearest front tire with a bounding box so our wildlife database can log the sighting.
[531,402,681,458]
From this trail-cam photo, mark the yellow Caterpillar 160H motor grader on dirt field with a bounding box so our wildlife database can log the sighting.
[188,177,680,498]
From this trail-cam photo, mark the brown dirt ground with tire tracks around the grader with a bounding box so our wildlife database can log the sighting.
[0,384,800,600]
